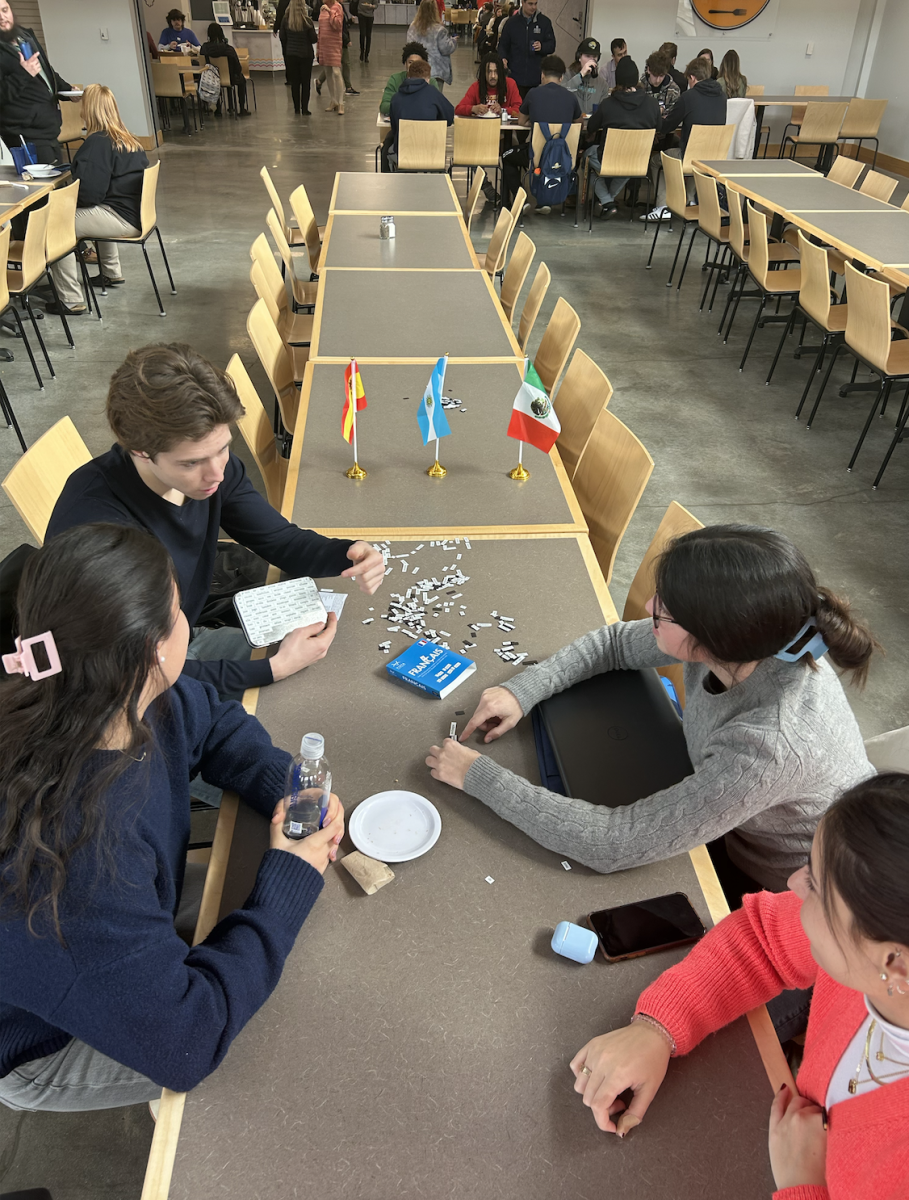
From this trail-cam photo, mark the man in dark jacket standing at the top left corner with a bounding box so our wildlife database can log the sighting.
[0,0,71,163]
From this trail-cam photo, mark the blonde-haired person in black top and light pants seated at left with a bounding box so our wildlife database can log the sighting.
[47,83,149,317]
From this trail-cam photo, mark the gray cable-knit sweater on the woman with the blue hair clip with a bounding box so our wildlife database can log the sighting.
[464,620,874,892]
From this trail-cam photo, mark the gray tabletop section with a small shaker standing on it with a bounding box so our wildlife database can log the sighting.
[321,214,475,270]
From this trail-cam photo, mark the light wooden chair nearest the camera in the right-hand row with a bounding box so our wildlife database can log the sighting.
[808,263,909,487]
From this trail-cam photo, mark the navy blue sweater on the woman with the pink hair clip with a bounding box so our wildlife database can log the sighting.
[0,679,323,1091]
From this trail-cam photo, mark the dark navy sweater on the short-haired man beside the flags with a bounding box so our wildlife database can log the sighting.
[47,445,353,695]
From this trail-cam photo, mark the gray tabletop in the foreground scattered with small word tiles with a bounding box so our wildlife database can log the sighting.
[170,539,772,1200]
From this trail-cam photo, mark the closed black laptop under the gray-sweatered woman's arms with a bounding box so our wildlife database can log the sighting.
[538,668,694,808]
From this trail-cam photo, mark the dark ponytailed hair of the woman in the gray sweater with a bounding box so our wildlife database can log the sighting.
[655,524,878,686]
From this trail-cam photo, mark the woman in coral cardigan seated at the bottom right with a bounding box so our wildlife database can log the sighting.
[571,774,909,1200]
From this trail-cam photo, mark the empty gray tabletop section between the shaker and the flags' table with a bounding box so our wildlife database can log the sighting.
[312,270,517,361]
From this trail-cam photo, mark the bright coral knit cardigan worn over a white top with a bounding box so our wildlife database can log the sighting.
[637,892,909,1200]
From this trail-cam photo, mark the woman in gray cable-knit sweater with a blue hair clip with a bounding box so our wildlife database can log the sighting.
[426,526,875,892]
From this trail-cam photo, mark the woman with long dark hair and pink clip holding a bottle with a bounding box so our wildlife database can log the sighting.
[0,524,344,1111]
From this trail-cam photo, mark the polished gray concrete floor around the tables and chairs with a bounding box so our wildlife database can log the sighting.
[0,26,909,1200]
